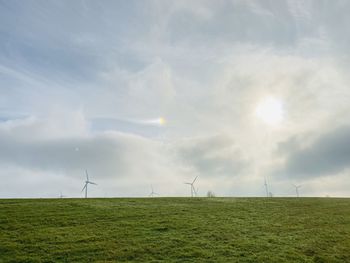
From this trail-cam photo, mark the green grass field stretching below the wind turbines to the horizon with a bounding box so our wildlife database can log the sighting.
[0,198,350,263]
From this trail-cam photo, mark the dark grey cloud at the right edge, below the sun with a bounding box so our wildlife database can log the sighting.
[278,126,350,177]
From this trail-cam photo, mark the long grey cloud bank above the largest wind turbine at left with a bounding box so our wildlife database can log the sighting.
[0,124,163,177]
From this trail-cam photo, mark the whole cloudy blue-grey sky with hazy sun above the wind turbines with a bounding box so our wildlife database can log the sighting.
[0,0,350,198]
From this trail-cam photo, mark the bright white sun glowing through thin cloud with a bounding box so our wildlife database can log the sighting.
[255,96,284,126]
